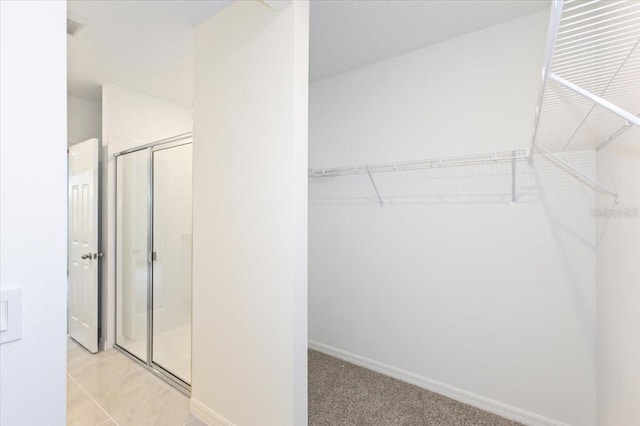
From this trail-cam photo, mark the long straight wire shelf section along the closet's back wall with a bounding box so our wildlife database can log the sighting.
[308,149,529,177]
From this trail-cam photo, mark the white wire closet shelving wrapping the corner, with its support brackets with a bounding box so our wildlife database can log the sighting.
[308,0,640,204]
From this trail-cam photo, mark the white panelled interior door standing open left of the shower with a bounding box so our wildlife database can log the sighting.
[68,139,102,353]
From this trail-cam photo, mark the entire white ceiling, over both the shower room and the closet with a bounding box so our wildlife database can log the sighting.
[68,0,550,105]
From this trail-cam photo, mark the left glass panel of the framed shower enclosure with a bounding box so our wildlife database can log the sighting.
[116,150,149,362]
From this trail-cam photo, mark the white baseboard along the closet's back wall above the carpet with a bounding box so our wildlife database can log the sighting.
[309,340,569,426]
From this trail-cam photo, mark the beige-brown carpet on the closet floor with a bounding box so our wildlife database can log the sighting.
[309,351,519,426]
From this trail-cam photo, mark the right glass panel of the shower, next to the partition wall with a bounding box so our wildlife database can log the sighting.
[152,144,192,383]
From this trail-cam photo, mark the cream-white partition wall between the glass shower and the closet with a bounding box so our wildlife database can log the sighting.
[191,1,309,426]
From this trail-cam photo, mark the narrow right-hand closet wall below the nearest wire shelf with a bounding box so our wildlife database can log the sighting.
[596,127,640,425]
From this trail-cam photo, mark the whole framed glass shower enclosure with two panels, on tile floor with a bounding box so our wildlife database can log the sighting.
[116,134,192,391]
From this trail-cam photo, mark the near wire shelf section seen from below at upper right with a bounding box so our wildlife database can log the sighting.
[530,0,640,153]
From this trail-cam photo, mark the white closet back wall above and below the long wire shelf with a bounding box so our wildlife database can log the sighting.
[309,11,595,425]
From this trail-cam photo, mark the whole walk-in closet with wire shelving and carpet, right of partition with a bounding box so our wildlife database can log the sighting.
[308,0,640,425]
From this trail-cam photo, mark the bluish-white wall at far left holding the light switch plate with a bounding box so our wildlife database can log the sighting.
[0,1,67,426]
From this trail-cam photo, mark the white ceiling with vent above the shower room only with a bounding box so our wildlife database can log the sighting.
[67,0,231,106]
